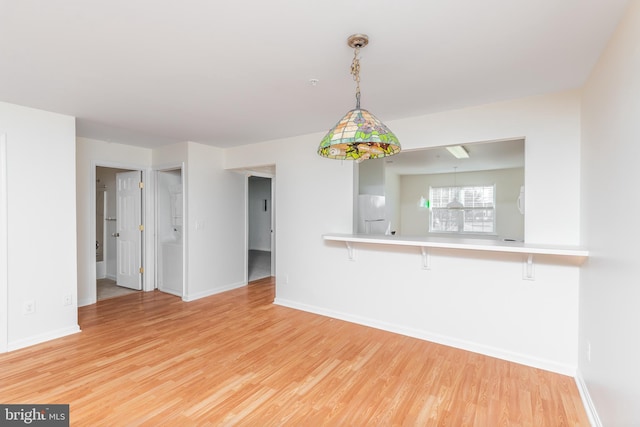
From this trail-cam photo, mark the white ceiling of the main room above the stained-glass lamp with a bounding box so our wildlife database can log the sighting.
[0,0,628,147]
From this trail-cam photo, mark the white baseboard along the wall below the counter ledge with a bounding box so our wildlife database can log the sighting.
[273,298,576,377]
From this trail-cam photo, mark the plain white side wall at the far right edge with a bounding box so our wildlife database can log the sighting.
[580,1,640,426]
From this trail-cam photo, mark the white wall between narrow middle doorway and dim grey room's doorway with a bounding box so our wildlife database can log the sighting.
[184,142,247,300]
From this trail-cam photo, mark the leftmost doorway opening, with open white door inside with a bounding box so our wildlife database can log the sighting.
[95,166,144,301]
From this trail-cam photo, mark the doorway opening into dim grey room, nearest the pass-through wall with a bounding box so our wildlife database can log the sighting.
[247,176,275,282]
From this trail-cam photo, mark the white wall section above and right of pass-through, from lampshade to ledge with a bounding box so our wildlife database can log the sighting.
[389,91,580,245]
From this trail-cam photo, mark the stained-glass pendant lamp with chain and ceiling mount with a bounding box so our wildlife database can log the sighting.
[318,34,400,162]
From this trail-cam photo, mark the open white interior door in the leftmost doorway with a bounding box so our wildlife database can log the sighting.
[116,171,142,290]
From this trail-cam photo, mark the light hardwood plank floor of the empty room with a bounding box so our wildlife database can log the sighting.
[0,278,589,427]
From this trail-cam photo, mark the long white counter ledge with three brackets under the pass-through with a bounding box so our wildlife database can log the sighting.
[322,234,589,280]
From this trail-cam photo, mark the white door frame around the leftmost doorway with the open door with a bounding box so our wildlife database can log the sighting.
[88,160,155,304]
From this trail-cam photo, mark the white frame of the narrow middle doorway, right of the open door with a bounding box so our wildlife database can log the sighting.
[152,162,189,299]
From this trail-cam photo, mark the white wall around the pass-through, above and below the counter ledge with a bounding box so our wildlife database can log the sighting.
[226,91,580,374]
